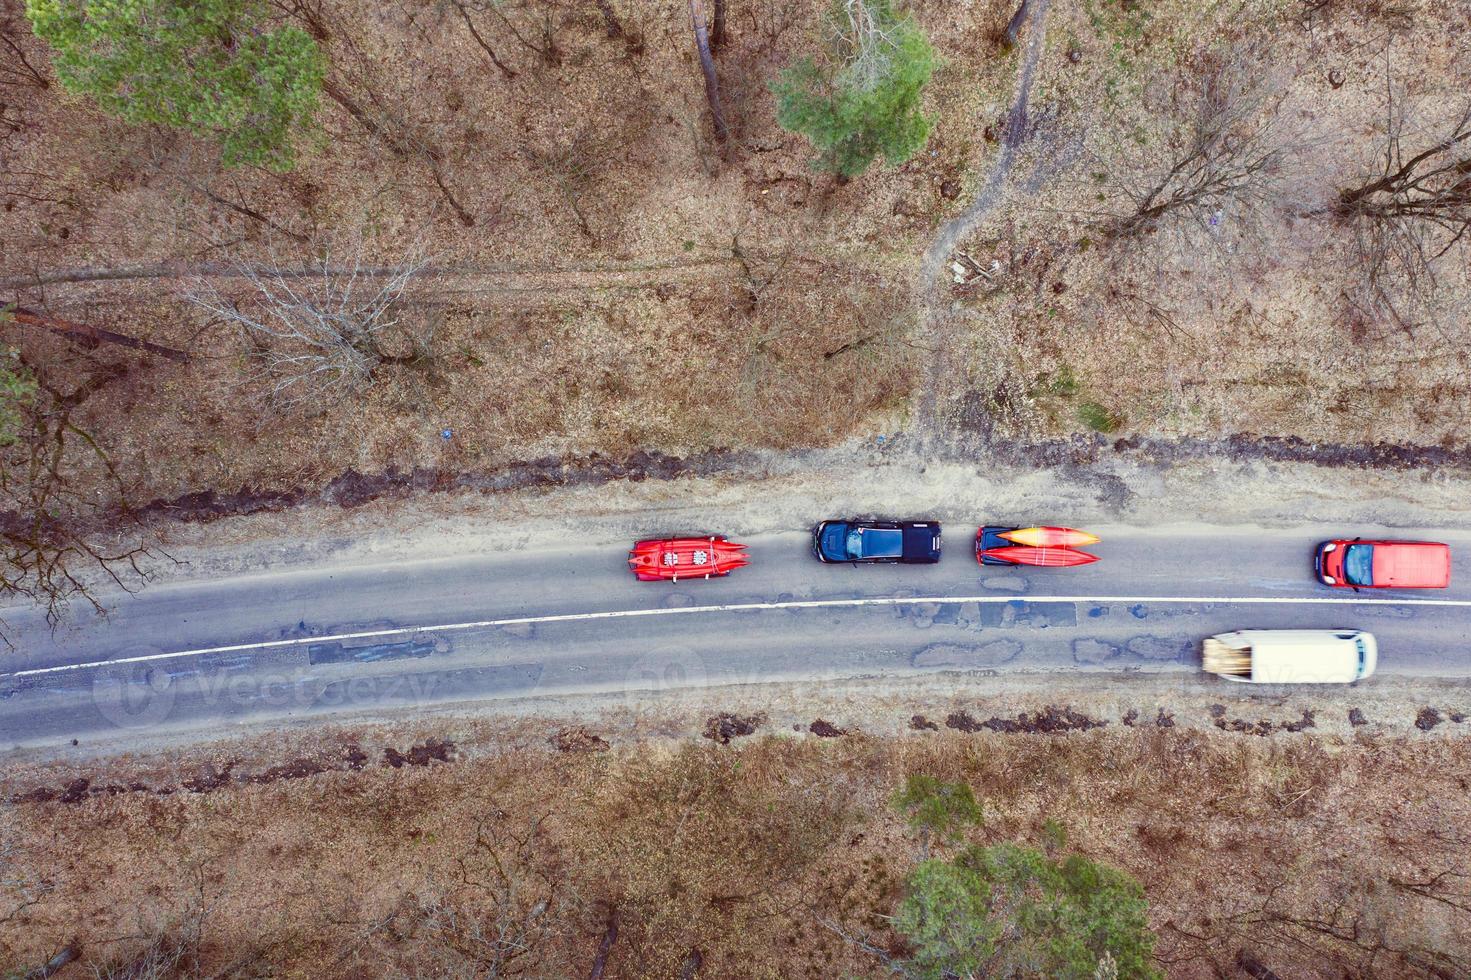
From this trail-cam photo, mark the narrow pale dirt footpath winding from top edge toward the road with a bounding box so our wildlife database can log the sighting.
[915,0,1050,441]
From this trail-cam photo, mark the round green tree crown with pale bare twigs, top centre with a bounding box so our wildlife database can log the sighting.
[772,0,936,177]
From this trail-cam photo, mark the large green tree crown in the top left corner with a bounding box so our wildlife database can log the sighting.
[25,0,327,171]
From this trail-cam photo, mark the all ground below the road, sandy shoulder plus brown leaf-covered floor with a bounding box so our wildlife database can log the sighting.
[0,675,1471,977]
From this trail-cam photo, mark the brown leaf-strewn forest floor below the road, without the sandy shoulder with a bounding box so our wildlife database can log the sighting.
[0,728,1471,977]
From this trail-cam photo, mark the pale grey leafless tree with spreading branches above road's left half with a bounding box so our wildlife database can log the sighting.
[185,243,428,409]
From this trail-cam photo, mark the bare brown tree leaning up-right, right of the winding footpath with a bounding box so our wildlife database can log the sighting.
[1105,53,1293,238]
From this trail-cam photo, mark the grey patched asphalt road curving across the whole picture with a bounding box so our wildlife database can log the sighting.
[0,525,1471,745]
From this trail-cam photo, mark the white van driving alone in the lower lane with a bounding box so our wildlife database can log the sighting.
[1203,630,1378,684]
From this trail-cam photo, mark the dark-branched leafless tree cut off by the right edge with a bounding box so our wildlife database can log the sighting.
[1334,78,1471,330]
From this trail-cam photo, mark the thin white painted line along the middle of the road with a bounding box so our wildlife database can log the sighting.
[11,596,1471,680]
